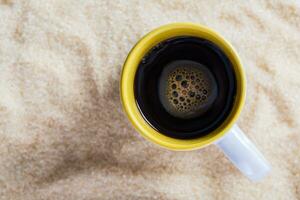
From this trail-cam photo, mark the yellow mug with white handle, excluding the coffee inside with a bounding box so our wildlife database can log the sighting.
[120,23,270,181]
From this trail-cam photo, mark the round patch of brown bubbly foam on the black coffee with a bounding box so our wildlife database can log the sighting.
[159,60,217,119]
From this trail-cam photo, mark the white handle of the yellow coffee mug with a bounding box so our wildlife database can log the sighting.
[215,125,271,181]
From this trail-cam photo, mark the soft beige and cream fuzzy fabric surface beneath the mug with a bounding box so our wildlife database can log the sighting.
[0,0,300,200]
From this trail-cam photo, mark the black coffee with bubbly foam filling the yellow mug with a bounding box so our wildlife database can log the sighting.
[135,36,236,139]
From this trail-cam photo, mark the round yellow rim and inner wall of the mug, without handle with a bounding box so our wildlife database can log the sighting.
[120,22,246,150]
